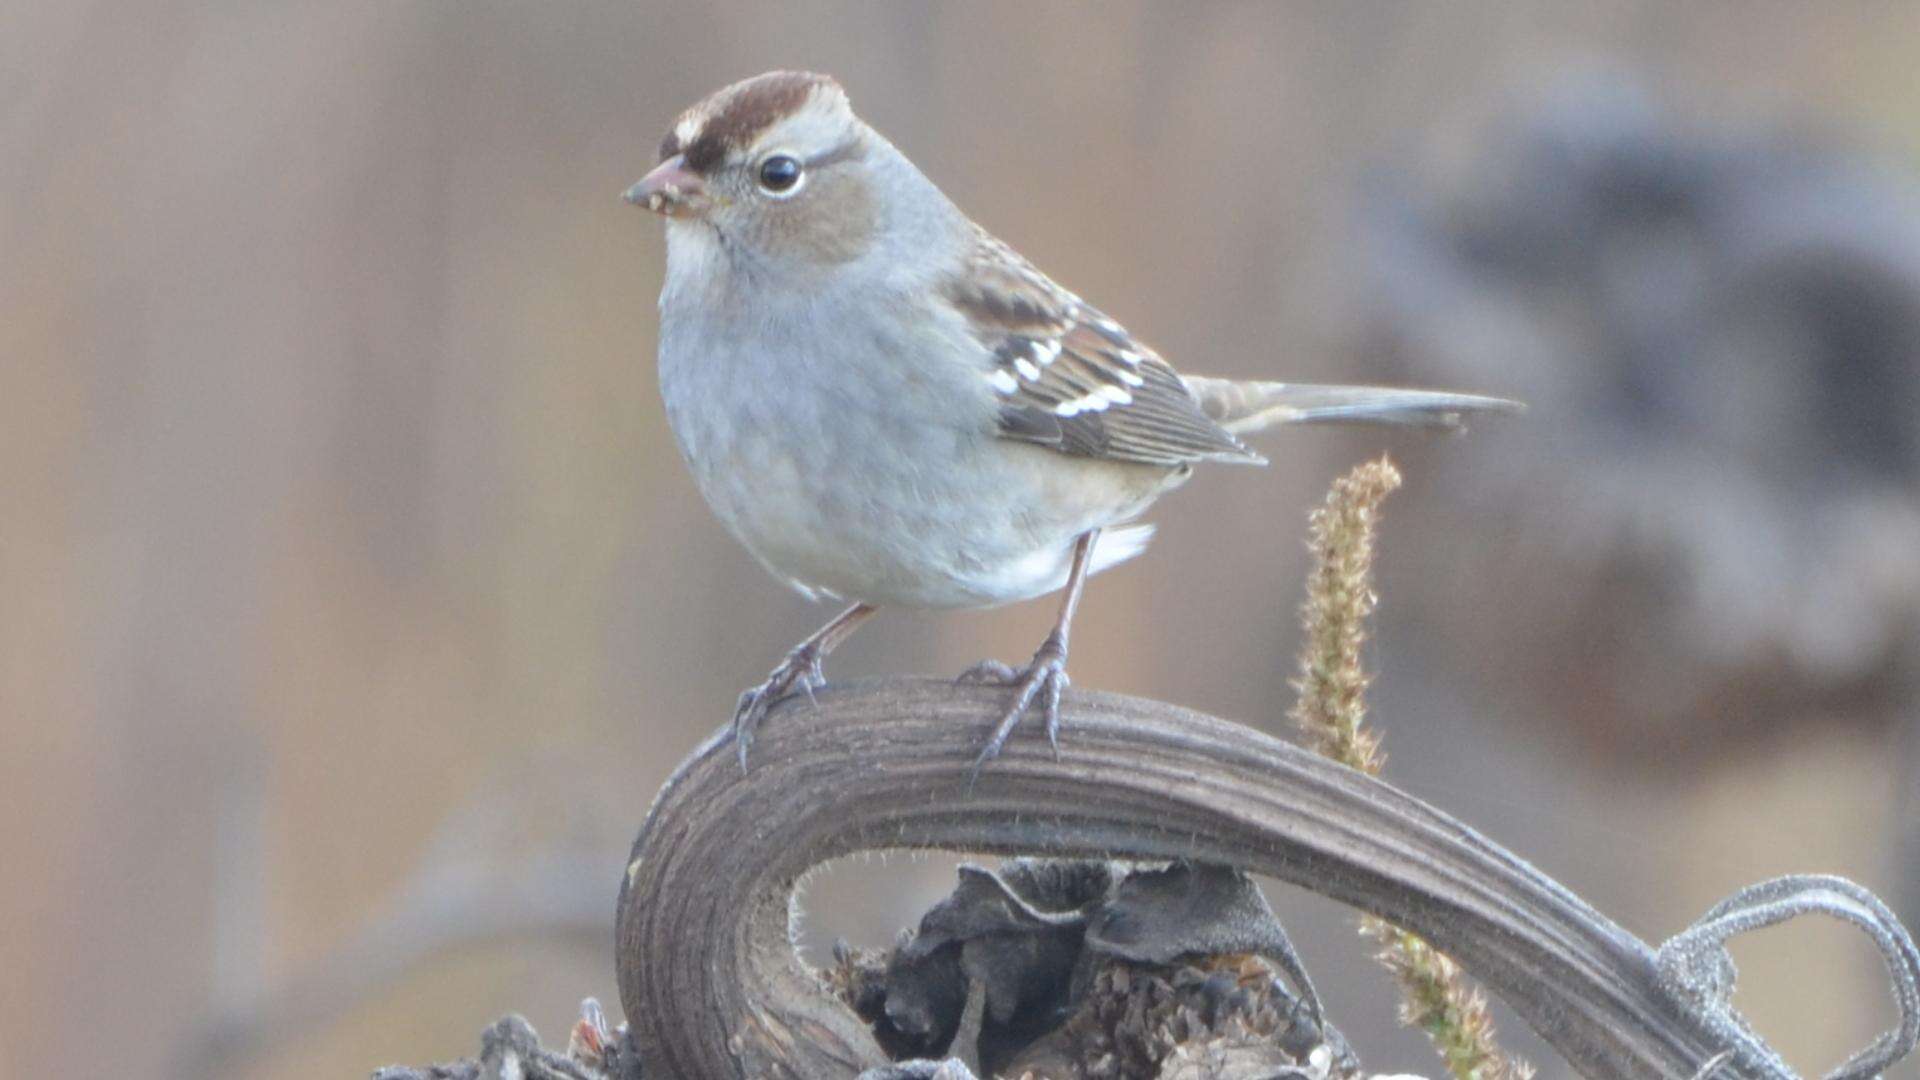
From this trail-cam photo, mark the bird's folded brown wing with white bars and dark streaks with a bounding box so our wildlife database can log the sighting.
[945,233,1261,469]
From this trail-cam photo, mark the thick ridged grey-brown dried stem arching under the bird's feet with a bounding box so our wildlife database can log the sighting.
[616,680,1758,1080]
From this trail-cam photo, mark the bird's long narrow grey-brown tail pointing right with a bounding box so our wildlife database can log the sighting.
[1187,375,1526,434]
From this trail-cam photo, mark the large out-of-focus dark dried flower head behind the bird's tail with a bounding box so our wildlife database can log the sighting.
[1357,81,1920,767]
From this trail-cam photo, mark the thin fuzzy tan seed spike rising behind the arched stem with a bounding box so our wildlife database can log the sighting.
[1292,457,1534,1080]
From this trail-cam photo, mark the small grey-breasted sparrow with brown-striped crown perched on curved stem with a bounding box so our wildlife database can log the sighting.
[626,71,1517,774]
